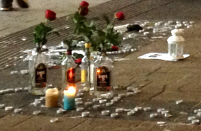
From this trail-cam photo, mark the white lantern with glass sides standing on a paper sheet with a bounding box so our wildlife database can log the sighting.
[167,29,185,60]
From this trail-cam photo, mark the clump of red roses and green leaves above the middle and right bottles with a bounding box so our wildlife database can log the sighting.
[73,1,125,51]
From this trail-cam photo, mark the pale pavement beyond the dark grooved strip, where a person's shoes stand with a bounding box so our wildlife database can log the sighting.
[0,0,109,37]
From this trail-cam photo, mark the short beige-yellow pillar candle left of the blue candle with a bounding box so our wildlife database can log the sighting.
[45,88,59,107]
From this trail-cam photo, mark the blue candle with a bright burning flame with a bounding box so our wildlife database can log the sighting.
[64,86,76,110]
